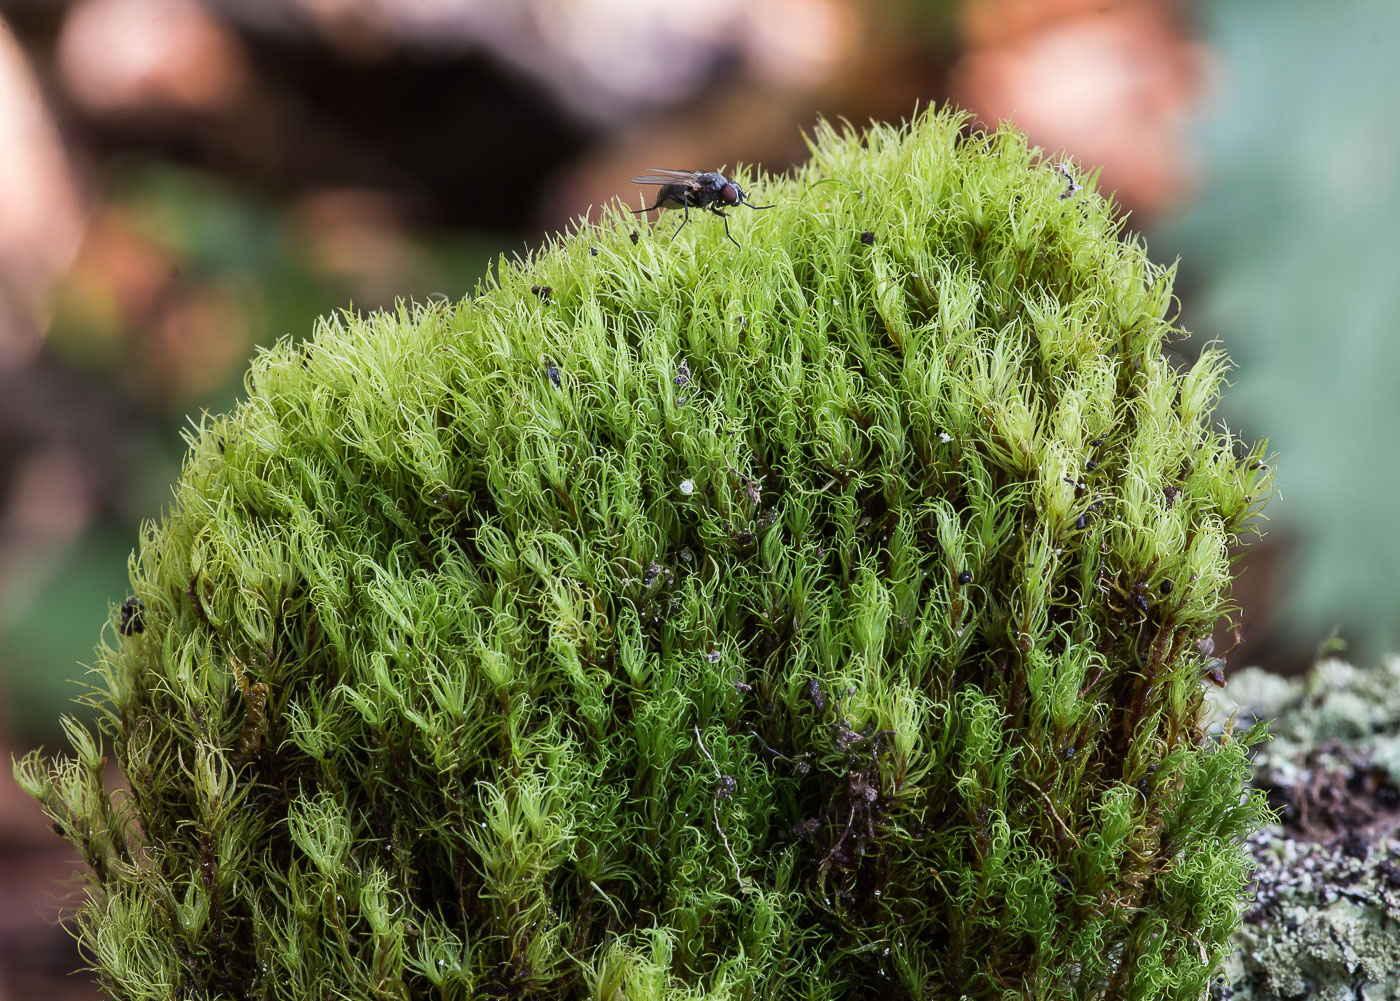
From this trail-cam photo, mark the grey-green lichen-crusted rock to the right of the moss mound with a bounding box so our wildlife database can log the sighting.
[1215,658,1400,1001]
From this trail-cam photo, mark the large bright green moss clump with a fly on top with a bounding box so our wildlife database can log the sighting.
[18,113,1270,1001]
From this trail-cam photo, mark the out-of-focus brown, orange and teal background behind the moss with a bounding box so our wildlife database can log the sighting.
[0,0,1400,1001]
